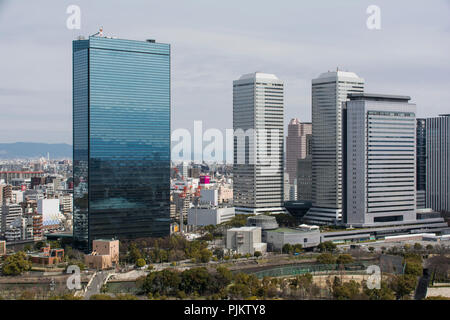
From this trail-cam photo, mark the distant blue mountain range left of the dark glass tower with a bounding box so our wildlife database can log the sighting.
[0,142,72,159]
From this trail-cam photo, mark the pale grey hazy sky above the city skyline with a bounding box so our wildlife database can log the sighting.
[0,0,450,143]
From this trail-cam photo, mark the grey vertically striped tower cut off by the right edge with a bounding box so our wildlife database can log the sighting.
[426,114,450,212]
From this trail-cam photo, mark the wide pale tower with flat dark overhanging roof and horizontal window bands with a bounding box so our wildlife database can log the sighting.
[345,93,416,227]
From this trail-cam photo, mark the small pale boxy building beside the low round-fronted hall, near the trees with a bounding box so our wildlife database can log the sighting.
[226,227,267,254]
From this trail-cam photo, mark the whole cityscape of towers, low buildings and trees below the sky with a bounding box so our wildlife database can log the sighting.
[0,30,450,300]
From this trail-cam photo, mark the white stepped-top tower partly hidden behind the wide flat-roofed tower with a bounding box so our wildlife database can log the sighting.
[304,70,364,224]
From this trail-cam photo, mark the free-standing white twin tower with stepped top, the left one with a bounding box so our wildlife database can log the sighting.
[233,72,284,214]
